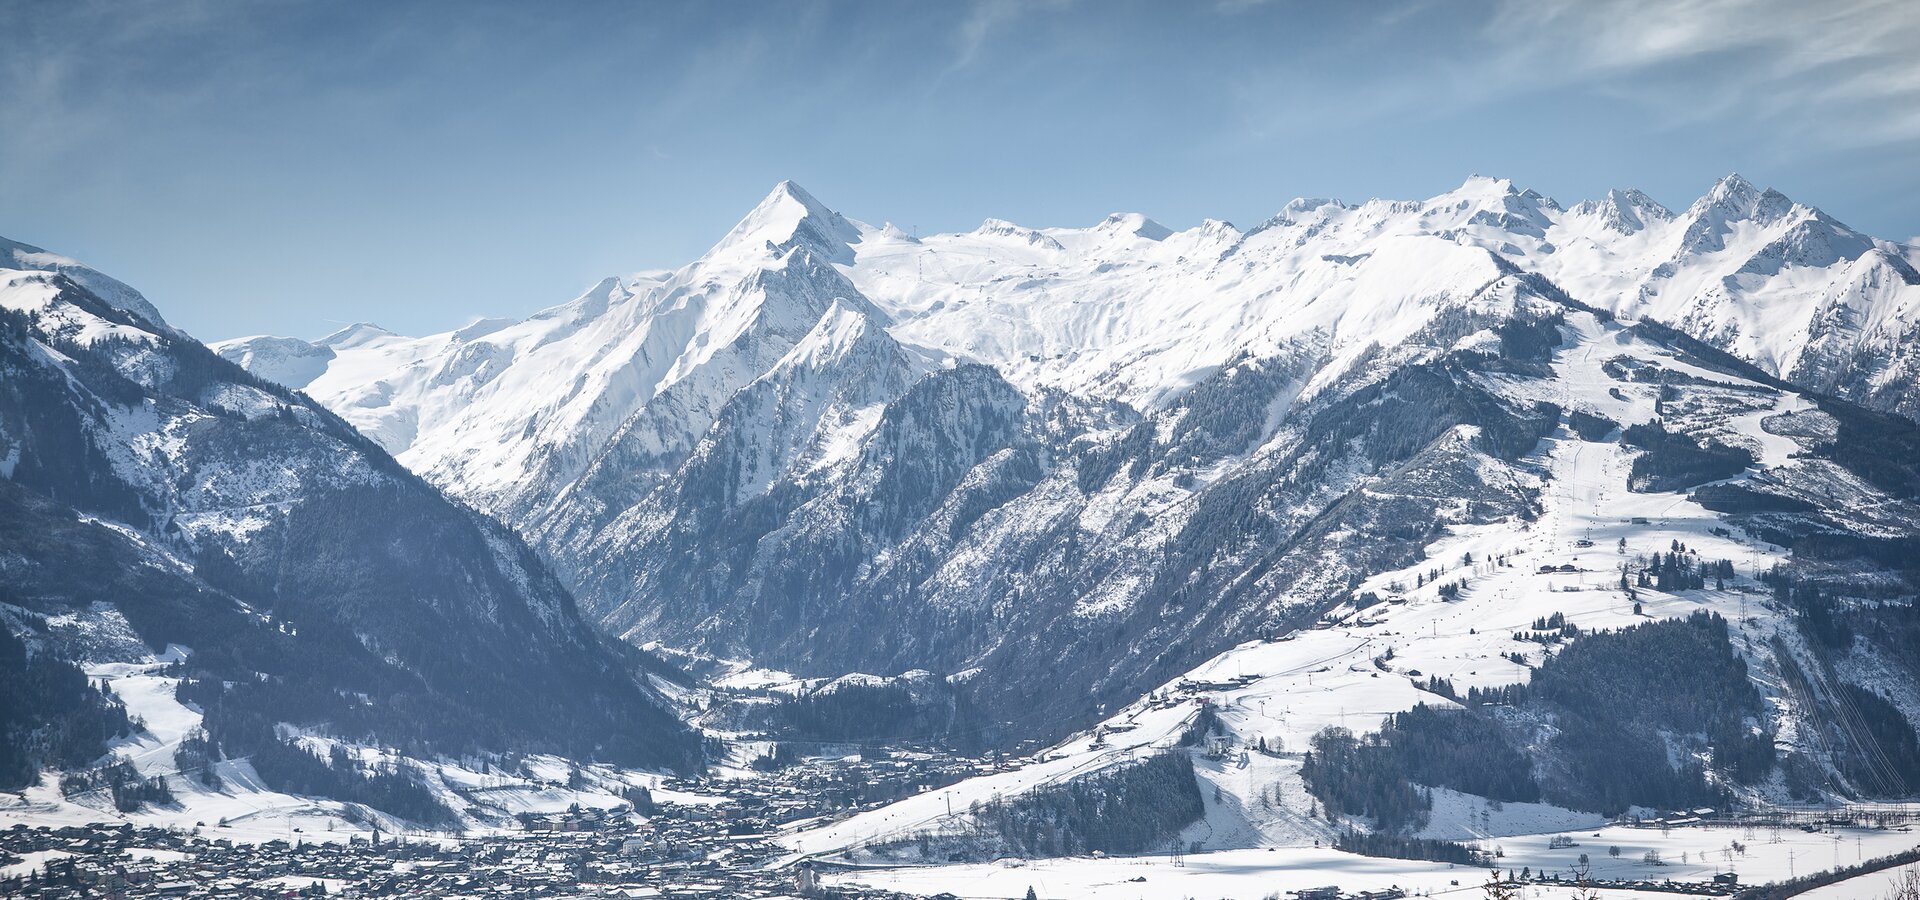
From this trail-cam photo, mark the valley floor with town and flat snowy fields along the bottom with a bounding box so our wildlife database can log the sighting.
[0,736,1920,900]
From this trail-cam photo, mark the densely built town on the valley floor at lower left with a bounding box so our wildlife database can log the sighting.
[0,750,995,900]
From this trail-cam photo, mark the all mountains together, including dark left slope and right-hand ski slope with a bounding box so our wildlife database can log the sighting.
[0,171,1920,844]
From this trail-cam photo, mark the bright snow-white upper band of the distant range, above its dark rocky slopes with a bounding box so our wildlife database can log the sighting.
[232,177,1920,491]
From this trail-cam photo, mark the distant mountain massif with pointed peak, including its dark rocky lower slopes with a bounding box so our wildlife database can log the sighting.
[217,177,1920,736]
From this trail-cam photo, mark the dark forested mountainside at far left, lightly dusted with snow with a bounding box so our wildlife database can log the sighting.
[0,243,697,817]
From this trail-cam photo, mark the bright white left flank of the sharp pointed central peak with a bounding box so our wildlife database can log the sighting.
[215,184,879,520]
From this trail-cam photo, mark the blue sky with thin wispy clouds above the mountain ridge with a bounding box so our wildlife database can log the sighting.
[0,0,1920,340]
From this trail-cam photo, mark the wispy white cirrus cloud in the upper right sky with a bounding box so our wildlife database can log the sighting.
[1217,0,1920,150]
